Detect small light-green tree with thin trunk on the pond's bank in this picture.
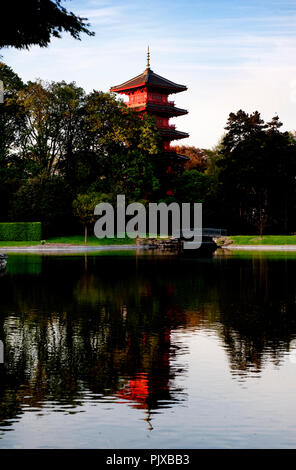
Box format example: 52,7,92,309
73,192,110,245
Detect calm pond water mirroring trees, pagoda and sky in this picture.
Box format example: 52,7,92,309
0,251,296,449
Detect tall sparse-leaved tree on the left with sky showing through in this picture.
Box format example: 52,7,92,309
17,81,85,175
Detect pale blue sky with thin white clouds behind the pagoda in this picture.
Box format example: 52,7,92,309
1,0,296,148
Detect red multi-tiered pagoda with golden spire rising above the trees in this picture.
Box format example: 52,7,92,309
110,48,189,160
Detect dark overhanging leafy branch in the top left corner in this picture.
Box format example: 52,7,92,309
0,0,94,49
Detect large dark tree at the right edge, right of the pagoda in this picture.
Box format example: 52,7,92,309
217,110,296,235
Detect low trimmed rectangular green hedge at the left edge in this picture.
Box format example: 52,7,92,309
0,222,42,241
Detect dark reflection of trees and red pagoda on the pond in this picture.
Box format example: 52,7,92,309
0,253,296,427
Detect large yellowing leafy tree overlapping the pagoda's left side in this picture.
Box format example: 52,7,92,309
78,91,160,199
